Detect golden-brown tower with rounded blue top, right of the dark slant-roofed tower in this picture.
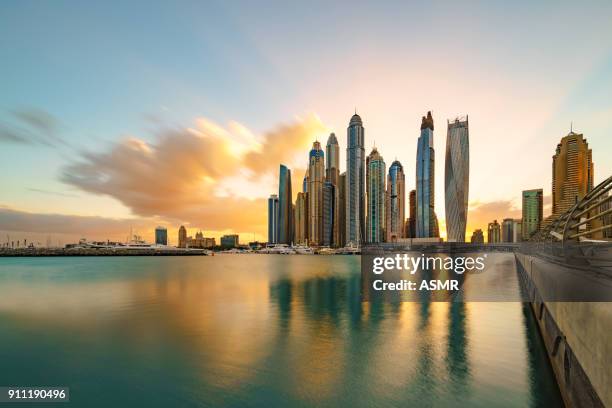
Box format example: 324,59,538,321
308,141,325,246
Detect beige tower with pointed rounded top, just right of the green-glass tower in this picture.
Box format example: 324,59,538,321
385,160,406,242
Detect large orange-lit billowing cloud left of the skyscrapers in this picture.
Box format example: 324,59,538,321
60,115,325,234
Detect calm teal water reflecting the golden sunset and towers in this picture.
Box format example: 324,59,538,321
0,255,562,407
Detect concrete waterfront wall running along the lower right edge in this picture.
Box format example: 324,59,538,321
515,252,612,407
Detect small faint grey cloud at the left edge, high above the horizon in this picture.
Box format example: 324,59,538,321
0,108,65,147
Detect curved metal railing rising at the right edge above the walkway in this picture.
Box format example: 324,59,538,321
530,176,612,242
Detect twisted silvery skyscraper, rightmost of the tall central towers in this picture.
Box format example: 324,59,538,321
444,116,470,242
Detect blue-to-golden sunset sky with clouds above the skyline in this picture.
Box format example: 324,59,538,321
0,0,612,245
